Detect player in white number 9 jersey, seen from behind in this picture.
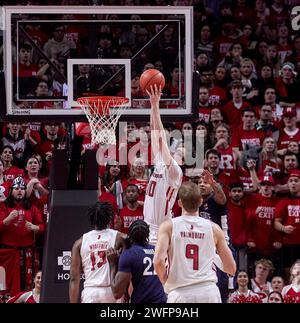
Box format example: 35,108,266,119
154,182,236,303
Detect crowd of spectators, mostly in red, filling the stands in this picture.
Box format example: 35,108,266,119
0,0,300,303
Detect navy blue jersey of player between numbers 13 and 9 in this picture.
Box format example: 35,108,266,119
118,245,167,303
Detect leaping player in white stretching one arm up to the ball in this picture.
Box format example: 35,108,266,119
144,85,182,245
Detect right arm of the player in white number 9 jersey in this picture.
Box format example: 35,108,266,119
212,222,236,276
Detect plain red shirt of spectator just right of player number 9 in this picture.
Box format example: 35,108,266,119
226,199,246,246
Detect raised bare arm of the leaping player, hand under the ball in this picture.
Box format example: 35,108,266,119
147,85,172,166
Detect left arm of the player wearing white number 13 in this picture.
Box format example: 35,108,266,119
69,238,82,303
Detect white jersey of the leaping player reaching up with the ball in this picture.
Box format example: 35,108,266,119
144,154,182,230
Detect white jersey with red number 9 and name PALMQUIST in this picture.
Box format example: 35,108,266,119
165,215,217,293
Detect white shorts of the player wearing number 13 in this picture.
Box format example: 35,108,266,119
81,287,122,303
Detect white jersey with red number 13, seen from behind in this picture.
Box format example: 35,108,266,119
80,229,118,287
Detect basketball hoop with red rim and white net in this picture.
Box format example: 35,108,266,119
77,96,129,145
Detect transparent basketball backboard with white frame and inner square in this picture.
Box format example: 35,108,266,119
1,6,196,121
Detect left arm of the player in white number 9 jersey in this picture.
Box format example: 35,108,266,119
153,220,172,284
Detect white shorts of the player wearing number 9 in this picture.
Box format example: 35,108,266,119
167,283,222,303
